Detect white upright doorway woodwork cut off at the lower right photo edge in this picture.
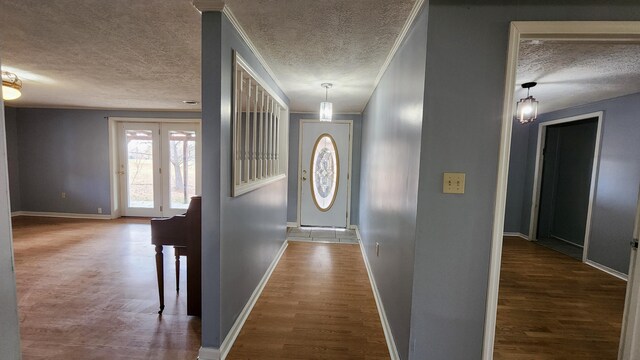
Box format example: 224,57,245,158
618,184,640,360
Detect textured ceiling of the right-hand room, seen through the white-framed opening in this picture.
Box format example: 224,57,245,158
516,40,640,113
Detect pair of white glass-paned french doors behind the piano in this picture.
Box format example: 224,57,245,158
118,122,200,217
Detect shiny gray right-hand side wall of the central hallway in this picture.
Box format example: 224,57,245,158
359,7,427,359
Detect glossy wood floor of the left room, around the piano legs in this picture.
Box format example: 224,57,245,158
11,217,200,360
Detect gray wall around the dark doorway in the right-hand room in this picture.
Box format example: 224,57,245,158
507,93,640,274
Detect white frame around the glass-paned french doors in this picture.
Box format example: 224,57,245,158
107,116,202,219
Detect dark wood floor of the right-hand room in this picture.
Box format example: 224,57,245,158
494,237,626,360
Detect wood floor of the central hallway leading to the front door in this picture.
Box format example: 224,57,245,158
227,242,389,360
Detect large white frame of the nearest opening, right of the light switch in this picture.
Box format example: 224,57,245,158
482,21,640,360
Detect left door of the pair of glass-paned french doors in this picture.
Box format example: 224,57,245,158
120,123,162,216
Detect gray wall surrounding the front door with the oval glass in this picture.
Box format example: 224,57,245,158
287,113,362,225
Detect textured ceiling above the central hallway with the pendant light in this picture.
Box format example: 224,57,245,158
227,0,415,112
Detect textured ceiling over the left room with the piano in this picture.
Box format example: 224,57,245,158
0,0,200,110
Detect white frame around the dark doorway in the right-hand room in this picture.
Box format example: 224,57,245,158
529,111,604,262
